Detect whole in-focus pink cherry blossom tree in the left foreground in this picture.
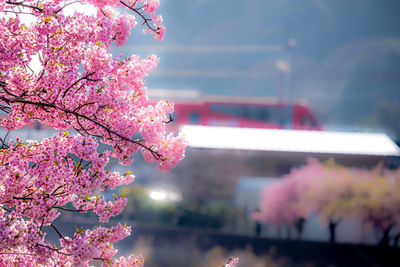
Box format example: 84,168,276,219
0,0,186,266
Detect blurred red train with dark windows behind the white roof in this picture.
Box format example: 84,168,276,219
155,96,323,130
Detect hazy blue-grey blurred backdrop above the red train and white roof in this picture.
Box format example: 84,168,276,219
129,0,400,140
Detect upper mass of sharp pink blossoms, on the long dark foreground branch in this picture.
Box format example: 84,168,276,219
0,1,185,172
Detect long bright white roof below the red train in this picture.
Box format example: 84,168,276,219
180,125,400,156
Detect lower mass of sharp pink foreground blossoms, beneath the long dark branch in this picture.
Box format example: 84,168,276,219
0,134,142,263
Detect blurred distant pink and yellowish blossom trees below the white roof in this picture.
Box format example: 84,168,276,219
254,159,400,245
